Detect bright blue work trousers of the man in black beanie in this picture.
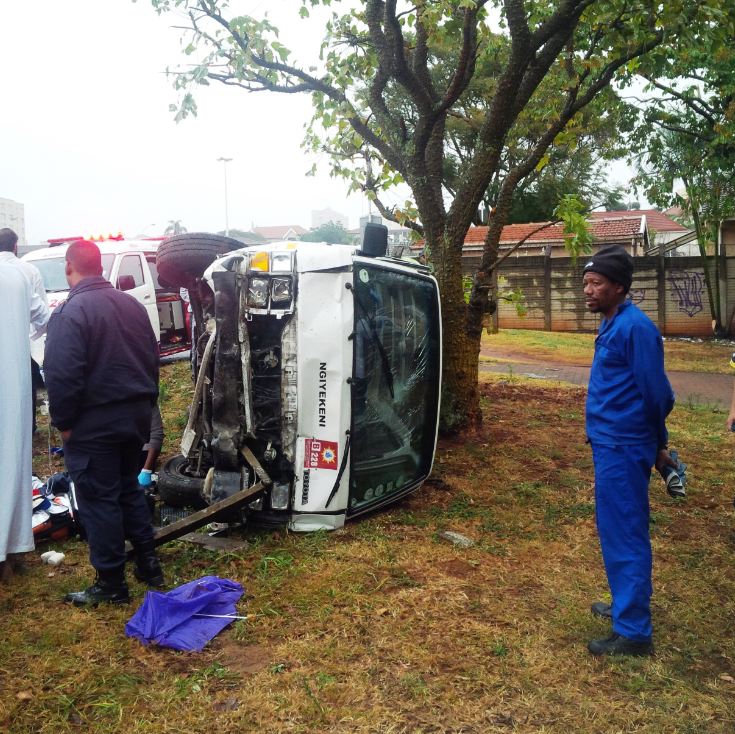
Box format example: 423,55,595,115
592,444,656,641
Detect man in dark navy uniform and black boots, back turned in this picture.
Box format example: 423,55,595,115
44,240,163,606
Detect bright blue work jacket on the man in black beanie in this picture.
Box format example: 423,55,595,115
587,301,674,448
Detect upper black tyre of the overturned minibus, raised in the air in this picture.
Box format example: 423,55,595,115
156,232,245,288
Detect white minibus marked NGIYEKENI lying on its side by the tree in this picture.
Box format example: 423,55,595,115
157,225,442,531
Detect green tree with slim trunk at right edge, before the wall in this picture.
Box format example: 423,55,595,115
634,44,735,335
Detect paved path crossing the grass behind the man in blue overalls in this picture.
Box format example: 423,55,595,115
480,362,733,410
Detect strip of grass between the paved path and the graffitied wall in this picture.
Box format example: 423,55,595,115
480,329,735,374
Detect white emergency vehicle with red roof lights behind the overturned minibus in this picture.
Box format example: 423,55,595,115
22,238,191,364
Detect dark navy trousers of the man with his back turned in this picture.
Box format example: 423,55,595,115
64,401,153,572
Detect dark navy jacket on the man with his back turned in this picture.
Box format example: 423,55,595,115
43,276,159,431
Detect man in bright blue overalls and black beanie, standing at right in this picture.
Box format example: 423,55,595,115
584,245,675,655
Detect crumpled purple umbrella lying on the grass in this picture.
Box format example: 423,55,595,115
125,576,243,652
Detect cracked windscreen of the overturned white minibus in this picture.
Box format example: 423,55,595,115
349,263,440,513
